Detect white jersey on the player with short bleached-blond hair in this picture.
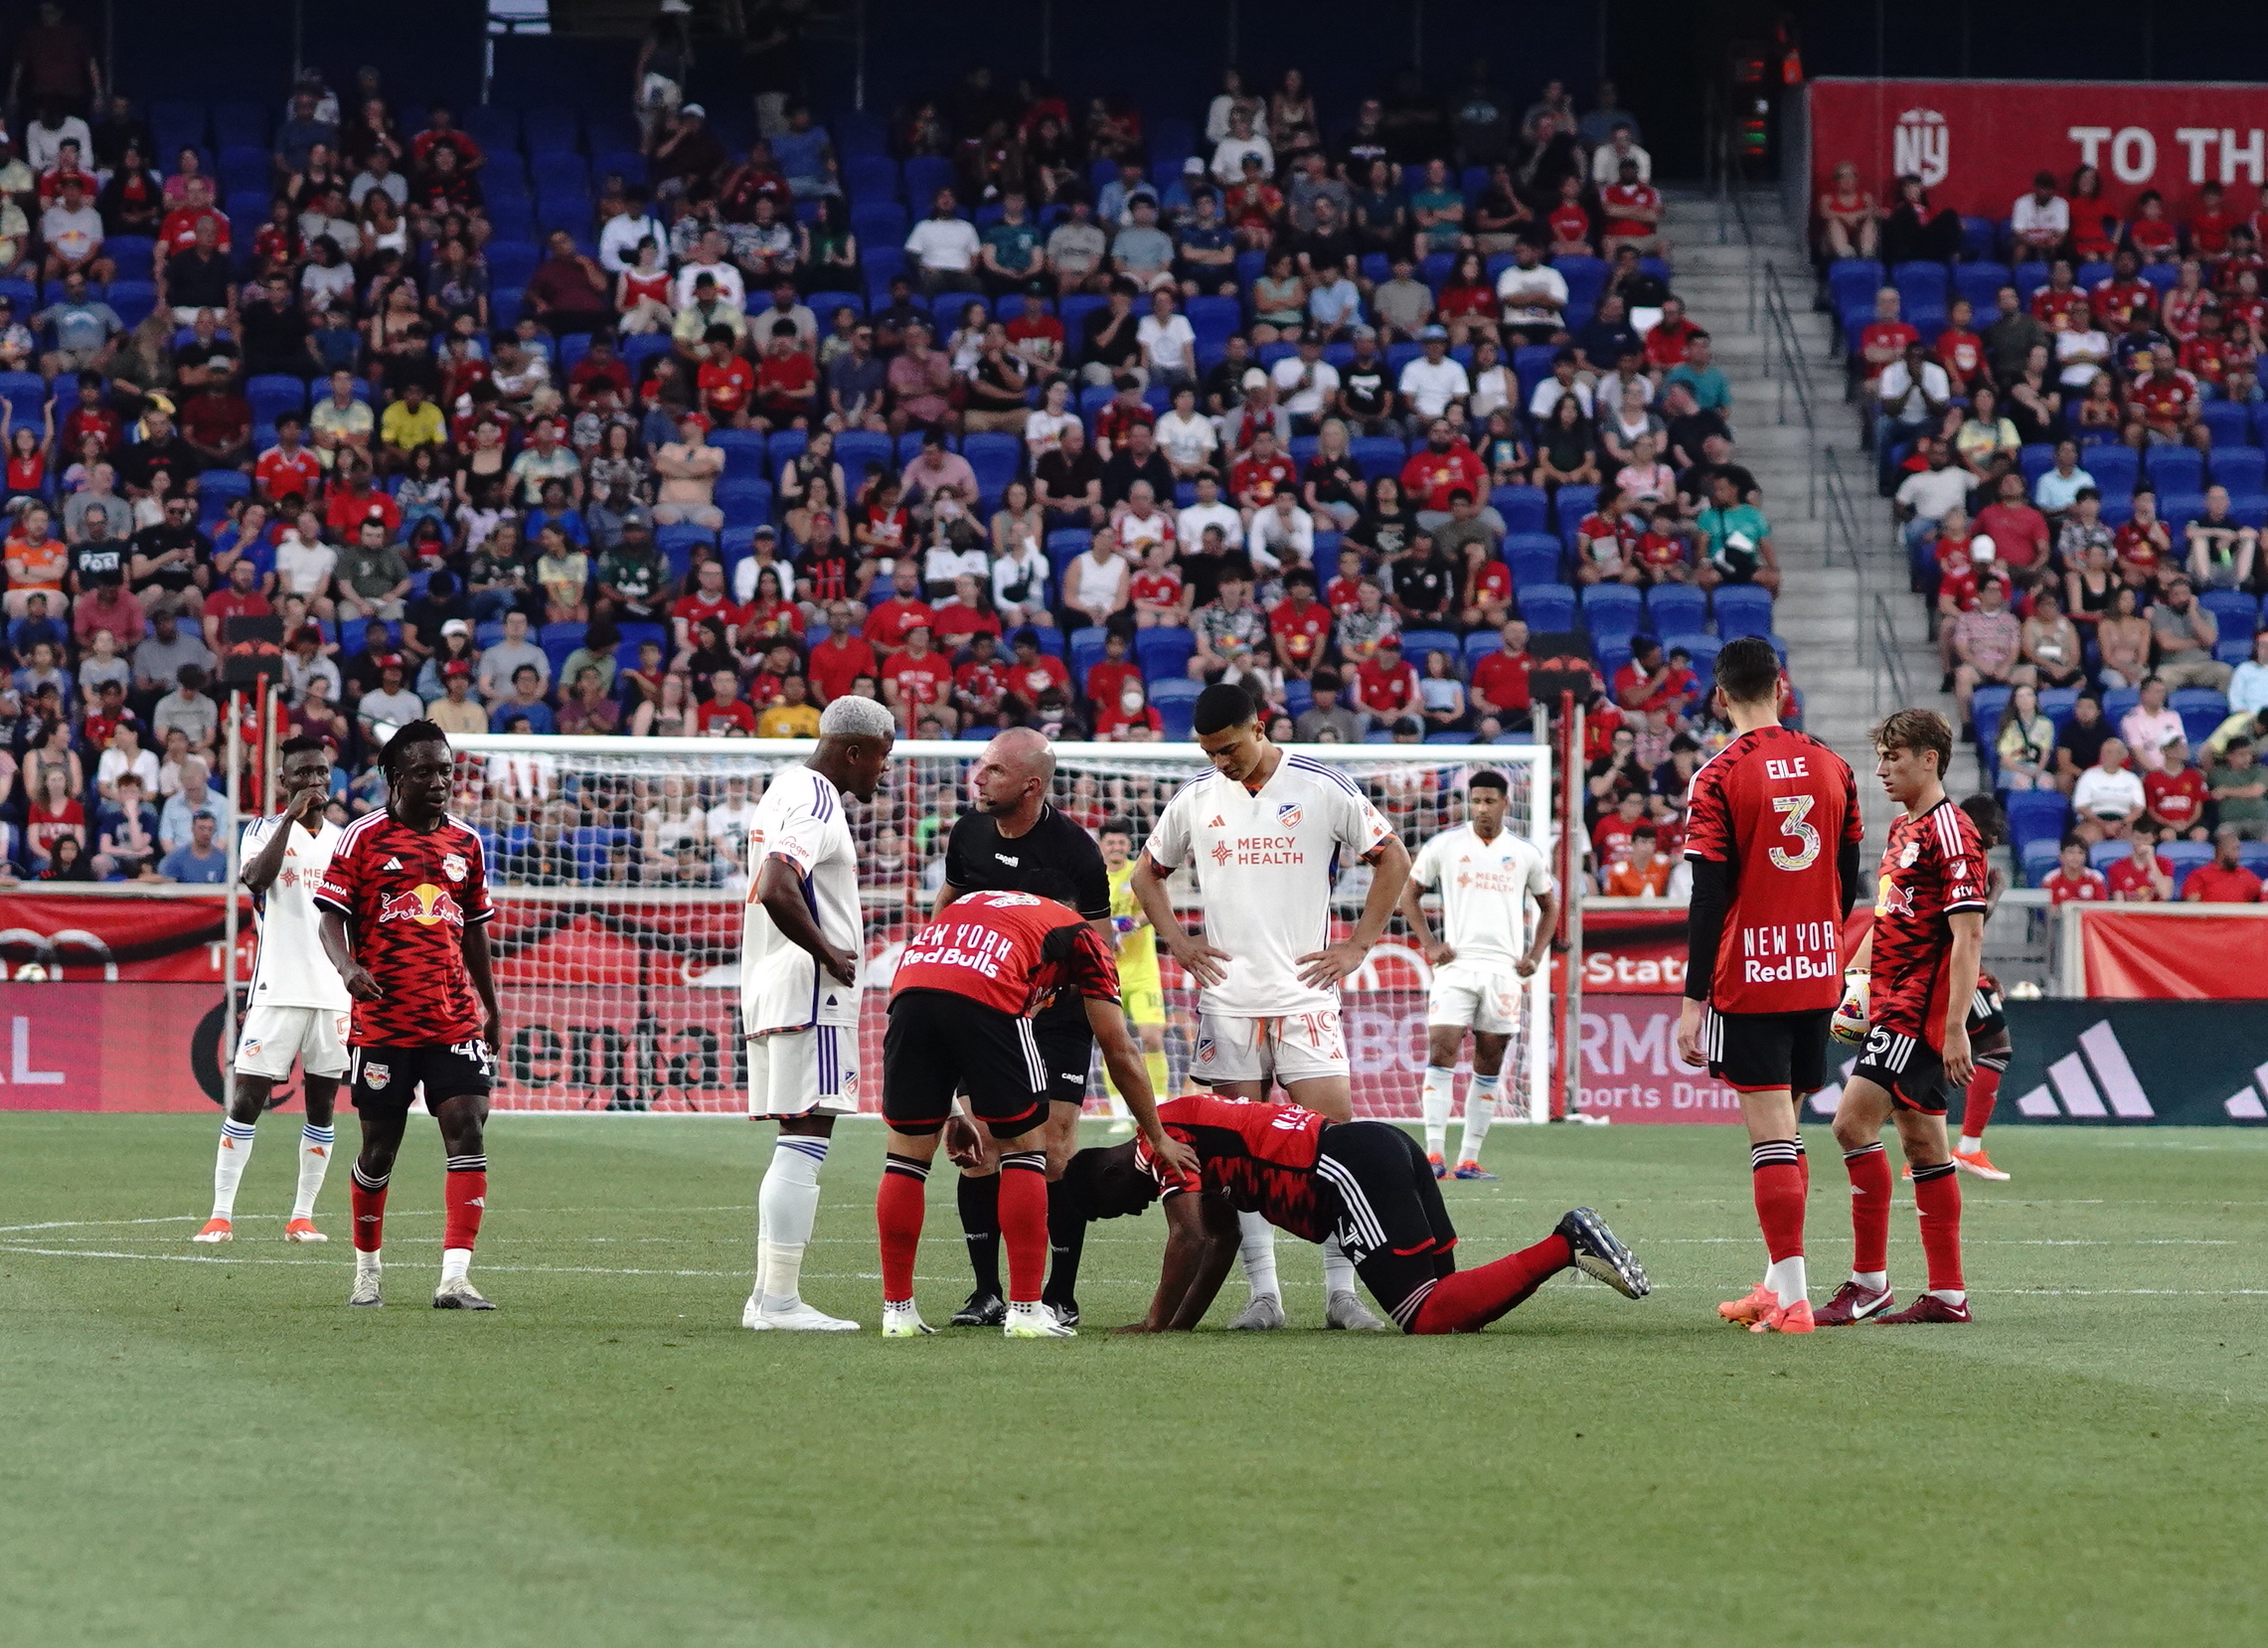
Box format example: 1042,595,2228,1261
739,761,867,1036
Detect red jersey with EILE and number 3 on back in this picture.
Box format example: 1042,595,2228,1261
1686,728,1864,1013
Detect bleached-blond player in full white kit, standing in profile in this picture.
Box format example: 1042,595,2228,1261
739,696,895,1333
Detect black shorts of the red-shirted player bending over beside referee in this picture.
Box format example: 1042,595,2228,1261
883,991,1052,1138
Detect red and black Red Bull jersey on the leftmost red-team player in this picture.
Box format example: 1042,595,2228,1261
315,811,497,1048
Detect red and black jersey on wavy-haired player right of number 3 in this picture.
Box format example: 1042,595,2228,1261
1866,795,1987,1052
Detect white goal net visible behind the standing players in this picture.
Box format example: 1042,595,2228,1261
432,737,1551,1120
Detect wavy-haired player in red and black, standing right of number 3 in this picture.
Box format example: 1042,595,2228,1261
1817,710,1987,1328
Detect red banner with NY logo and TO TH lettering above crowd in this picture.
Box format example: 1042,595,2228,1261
1805,80,2268,220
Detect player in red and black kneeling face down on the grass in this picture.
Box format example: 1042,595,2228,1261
1063,1095,1649,1333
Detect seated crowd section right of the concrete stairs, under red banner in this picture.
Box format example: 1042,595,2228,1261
1817,163,2268,903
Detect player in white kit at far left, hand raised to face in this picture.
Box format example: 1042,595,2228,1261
188,739,354,1242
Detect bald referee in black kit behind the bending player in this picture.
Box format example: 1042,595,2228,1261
930,728,1111,1328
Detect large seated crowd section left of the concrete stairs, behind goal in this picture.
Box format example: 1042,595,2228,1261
0,16,1805,880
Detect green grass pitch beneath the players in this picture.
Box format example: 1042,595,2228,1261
0,1113,2268,1648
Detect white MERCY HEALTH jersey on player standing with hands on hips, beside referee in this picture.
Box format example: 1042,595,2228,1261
1145,754,1392,1018
